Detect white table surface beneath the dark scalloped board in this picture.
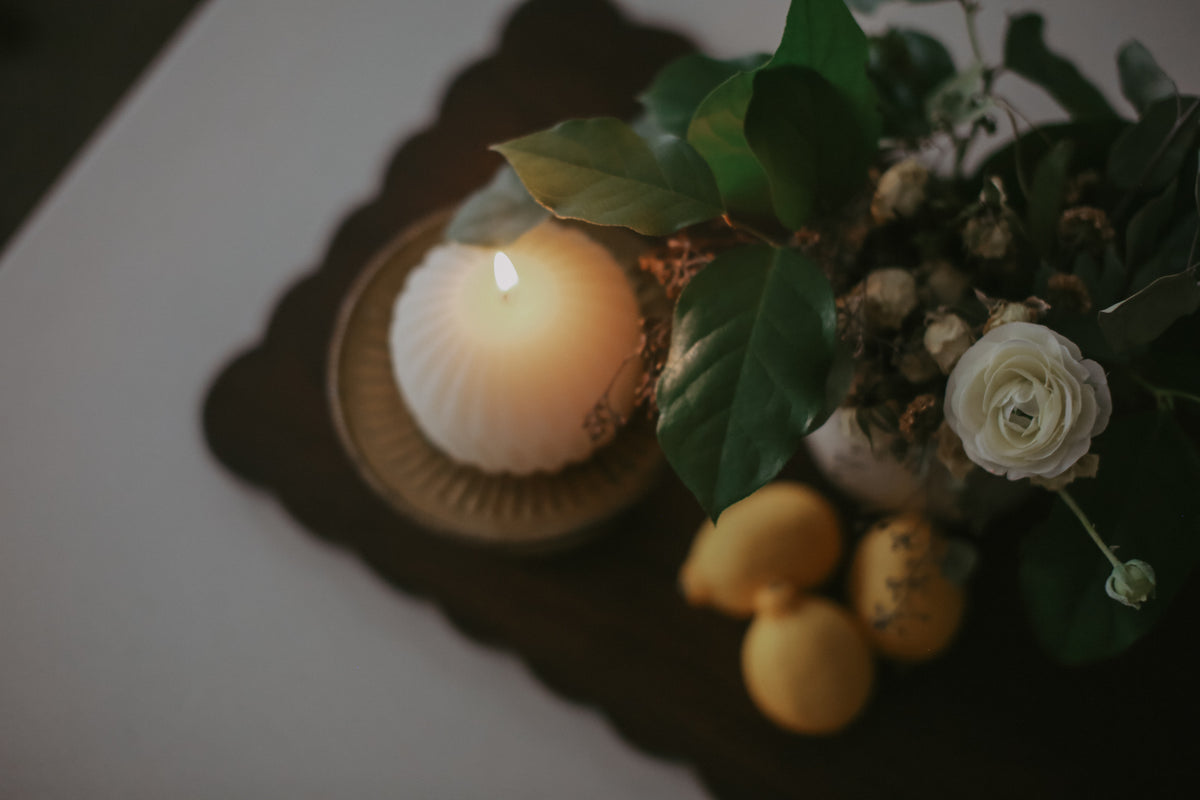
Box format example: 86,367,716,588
0,0,1200,800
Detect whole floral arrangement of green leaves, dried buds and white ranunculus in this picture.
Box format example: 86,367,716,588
448,0,1200,663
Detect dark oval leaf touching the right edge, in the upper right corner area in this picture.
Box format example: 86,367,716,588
1108,97,1200,192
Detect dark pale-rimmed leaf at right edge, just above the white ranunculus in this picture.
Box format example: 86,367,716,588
1099,269,1200,353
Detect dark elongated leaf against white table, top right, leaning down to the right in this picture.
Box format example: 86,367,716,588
1004,13,1116,118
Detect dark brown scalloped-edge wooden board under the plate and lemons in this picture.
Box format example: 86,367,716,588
204,0,1200,798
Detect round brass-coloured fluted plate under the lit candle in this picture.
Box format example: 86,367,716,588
328,211,664,551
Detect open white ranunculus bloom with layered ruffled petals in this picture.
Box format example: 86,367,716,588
946,323,1112,481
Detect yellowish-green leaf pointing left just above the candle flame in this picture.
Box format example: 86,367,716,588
492,118,722,236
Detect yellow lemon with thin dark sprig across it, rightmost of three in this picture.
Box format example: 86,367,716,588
850,513,965,662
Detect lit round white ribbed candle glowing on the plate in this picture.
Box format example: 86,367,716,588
391,221,641,475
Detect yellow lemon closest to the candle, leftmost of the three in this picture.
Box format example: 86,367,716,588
679,481,841,616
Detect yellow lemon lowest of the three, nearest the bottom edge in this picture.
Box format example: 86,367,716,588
742,596,875,734
